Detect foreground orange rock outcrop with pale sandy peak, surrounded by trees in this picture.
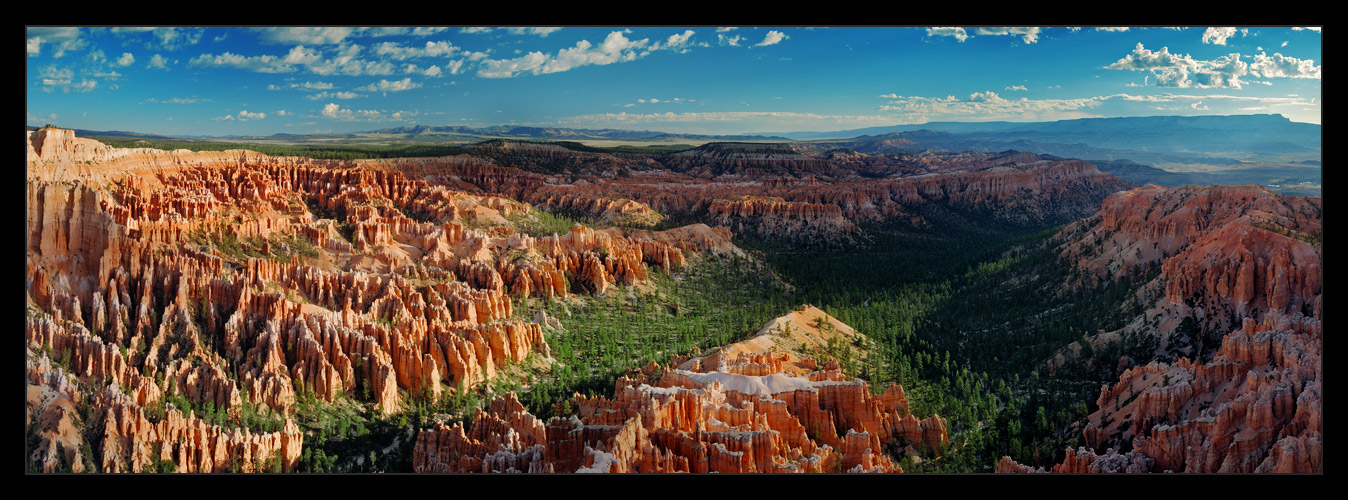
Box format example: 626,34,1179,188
414,307,949,473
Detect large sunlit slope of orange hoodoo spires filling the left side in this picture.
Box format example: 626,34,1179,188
24,129,740,472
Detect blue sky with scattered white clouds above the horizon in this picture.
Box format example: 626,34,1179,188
26,27,1322,136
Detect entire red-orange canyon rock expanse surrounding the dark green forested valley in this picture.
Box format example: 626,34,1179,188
24,128,1322,473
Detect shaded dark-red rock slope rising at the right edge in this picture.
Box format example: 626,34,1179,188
998,186,1324,473
